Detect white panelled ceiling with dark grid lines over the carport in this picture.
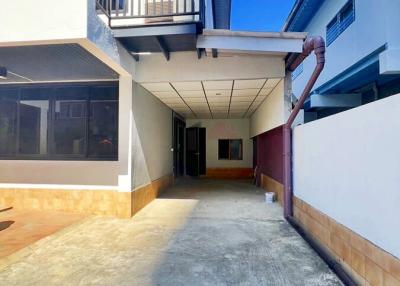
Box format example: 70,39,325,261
142,78,281,119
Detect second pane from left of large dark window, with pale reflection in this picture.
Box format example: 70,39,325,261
18,89,50,155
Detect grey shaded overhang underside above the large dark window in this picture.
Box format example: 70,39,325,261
0,44,118,84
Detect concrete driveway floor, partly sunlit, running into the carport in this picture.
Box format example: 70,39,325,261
0,179,342,286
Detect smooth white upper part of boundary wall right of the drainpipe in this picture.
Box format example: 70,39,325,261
293,95,400,257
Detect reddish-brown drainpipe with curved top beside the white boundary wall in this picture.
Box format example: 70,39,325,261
283,37,325,218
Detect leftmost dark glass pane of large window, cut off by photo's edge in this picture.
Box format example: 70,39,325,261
0,90,18,155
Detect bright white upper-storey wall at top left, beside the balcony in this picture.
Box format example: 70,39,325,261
0,0,135,76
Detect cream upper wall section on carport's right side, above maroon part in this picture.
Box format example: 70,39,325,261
250,79,287,137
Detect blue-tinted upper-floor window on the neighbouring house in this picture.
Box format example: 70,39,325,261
326,0,355,46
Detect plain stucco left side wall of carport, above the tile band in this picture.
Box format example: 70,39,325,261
132,83,173,189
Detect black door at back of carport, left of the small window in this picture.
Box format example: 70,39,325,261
186,127,206,176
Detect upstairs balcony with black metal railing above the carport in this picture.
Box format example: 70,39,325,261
96,0,205,61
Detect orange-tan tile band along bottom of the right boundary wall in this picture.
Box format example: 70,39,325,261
293,197,400,286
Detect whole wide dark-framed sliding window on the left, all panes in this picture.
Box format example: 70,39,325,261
0,83,118,160
